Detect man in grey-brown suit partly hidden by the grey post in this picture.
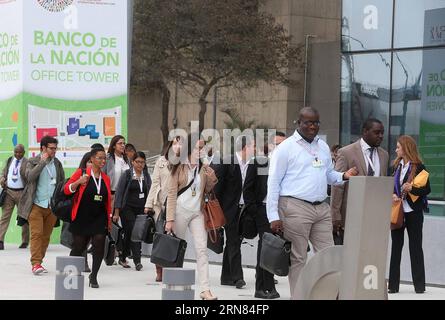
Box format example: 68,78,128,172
331,118,389,244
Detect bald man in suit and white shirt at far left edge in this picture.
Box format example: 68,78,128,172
0,144,29,250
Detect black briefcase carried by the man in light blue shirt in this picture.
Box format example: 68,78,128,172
260,232,291,277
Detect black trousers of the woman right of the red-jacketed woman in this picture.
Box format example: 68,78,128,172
119,206,144,264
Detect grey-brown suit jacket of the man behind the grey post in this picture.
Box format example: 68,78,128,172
331,139,389,227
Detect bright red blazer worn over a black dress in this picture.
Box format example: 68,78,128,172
63,168,111,226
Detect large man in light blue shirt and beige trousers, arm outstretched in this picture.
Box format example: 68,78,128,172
267,107,357,299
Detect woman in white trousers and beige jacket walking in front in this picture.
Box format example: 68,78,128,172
165,135,218,300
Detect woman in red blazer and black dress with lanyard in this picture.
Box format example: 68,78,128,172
64,149,111,288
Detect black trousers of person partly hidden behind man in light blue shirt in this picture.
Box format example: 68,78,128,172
255,205,275,291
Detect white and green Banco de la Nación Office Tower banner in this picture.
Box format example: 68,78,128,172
0,0,128,243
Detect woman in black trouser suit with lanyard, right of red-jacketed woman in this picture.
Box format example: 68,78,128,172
113,151,151,271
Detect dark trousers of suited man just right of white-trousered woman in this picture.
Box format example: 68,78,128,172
221,208,243,282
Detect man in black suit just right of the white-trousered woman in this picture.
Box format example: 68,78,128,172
215,135,255,289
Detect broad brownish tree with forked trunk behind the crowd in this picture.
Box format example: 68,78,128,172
132,0,301,142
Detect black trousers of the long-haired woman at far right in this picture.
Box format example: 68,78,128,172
388,211,425,291
